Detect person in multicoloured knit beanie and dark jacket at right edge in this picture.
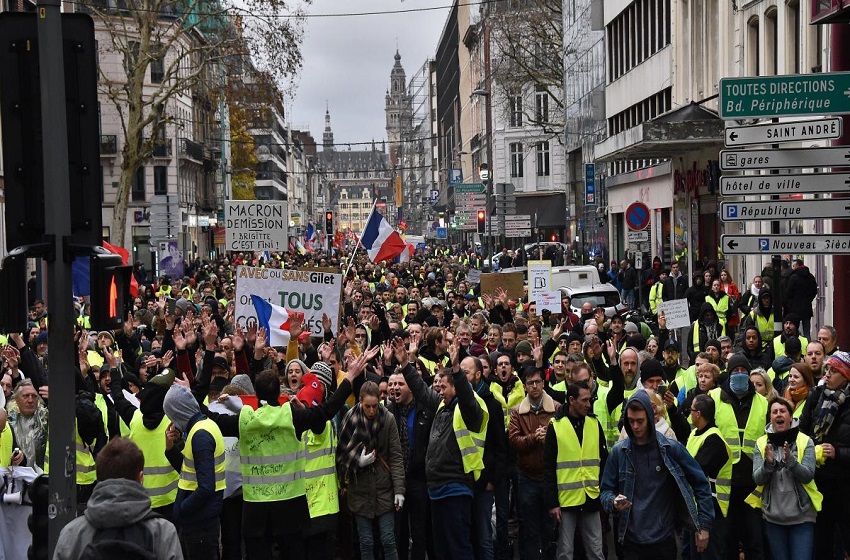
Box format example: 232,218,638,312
800,351,850,558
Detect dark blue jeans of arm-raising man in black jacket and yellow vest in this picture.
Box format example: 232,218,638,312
431,496,474,560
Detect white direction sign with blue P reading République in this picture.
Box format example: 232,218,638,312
720,198,850,222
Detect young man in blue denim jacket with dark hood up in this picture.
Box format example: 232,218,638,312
601,391,714,560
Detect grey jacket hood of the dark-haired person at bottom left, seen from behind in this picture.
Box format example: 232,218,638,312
85,478,151,529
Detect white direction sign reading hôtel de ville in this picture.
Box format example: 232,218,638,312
720,173,850,196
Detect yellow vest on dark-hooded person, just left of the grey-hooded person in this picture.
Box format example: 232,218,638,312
128,410,180,508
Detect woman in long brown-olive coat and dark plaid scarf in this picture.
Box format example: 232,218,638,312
337,381,404,560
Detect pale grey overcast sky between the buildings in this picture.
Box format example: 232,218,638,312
287,0,451,150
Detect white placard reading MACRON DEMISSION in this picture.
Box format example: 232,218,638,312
224,200,289,251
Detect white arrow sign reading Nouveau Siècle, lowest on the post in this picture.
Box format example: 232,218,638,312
720,234,850,255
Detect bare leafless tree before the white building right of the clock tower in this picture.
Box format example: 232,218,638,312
487,0,564,142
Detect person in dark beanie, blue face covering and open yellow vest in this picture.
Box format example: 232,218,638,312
708,353,768,558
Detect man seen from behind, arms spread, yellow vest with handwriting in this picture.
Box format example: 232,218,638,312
200,347,380,558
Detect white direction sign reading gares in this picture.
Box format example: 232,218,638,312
720,146,850,171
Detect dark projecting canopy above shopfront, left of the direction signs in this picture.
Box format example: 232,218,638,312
596,102,725,162
